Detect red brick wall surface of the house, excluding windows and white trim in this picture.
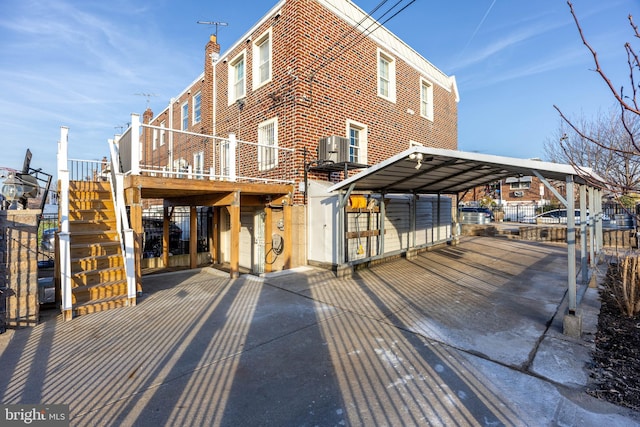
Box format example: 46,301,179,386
145,0,457,203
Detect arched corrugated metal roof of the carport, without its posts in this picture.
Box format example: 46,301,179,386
328,146,604,194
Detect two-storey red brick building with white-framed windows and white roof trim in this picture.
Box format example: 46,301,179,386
143,0,458,204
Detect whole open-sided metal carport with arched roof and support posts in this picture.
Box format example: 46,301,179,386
328,146,605,335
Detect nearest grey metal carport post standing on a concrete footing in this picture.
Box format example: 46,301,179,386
563,175,582,338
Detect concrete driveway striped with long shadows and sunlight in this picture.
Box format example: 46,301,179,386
0,237,640,427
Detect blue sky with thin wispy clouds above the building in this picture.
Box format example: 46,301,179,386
0,0,640,176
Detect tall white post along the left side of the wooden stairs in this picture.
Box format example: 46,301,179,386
57,126,73,320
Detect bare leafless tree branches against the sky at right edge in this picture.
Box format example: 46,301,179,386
547,1,640,195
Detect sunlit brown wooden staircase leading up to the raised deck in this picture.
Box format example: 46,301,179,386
69,181,128,316
